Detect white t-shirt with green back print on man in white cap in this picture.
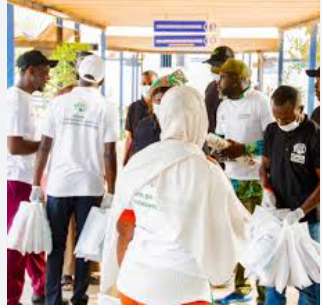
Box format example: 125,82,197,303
42,87,118,197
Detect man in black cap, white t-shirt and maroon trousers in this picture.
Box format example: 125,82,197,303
7,50,57,305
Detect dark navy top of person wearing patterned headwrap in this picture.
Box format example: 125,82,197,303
134,114,161,153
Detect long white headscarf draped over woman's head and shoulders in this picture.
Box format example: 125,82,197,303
101,86,249,295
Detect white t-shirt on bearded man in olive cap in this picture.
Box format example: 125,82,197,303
216,88,274,180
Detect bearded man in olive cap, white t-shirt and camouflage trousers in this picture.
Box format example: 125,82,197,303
216,59,273,305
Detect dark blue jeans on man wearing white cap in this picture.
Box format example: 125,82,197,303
46,196,102,305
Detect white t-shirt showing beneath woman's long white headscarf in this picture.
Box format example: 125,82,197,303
117,180,211,305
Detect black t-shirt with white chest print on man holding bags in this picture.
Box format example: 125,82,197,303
264,117,320,222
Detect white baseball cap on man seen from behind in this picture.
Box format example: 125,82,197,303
78,55,105,84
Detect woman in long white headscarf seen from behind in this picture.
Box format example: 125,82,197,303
100,86,249,305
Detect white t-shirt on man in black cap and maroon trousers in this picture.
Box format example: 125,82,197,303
7,86,36,184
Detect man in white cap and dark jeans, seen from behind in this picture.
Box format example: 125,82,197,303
30,55,118,305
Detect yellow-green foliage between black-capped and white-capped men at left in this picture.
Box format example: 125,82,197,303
44,42,90,98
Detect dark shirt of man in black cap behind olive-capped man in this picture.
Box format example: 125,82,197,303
205,81,222,133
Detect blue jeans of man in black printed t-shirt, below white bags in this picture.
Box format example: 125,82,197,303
265,223,320,305
